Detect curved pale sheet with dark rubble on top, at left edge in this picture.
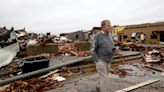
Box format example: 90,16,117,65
0,28,19,67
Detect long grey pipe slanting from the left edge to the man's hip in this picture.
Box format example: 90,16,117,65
0,56,92,86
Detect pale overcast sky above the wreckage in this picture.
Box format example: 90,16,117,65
0,0,164,34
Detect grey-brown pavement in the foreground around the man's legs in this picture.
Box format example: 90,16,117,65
45,69,164,92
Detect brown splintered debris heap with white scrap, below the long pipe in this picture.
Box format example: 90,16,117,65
0,63,88,92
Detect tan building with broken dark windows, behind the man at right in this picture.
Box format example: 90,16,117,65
117,22,164,44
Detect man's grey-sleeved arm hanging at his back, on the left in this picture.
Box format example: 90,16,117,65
91,36,99,62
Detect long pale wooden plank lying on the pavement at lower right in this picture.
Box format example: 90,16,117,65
115,79,159,92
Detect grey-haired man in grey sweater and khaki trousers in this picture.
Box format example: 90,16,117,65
91,20,118,92
